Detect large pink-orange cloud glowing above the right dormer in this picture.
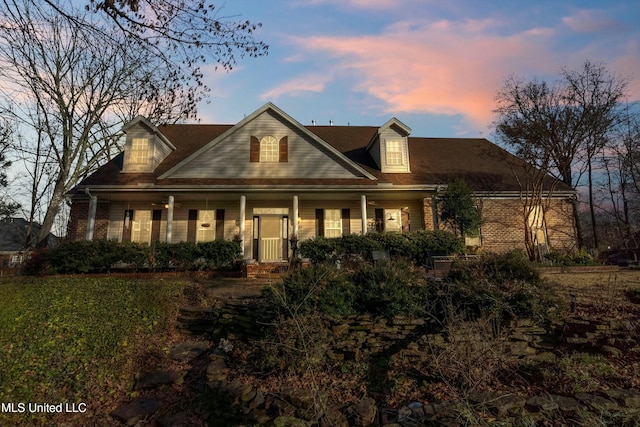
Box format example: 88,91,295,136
272,20,553,126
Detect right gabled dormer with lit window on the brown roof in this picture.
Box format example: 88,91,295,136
367,117,411,173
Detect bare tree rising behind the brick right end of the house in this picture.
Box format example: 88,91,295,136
494,61,626,251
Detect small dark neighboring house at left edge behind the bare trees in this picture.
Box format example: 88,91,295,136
0,218,57,268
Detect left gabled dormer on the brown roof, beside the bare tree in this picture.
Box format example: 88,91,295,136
122,116,176,173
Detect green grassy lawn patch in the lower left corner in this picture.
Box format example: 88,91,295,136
0,278,184,425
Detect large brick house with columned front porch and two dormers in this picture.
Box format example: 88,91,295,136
67,103,575,262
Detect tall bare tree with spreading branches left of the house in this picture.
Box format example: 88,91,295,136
0,0,268,238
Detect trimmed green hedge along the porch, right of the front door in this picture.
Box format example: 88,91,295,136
300,230,464,264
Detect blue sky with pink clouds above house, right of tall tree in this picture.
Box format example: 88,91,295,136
199,0,640,139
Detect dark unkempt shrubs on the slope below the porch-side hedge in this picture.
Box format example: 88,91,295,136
265,252,558,324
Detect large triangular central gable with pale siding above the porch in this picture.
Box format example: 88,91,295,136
159,103,376,180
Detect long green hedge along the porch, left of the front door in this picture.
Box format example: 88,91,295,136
22,240,240,275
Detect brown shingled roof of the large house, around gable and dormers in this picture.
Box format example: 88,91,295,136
72,124,572,192
